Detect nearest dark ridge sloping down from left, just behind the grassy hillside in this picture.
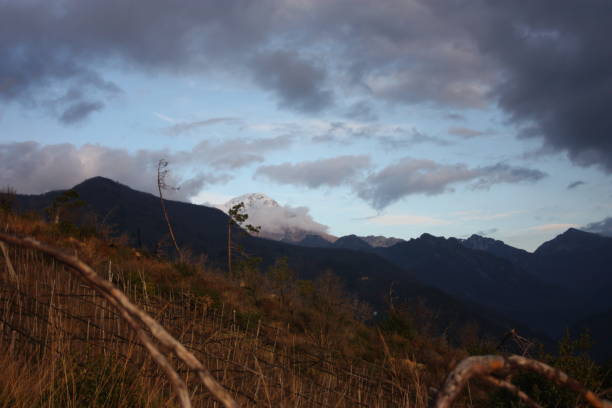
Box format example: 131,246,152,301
18,177,527,335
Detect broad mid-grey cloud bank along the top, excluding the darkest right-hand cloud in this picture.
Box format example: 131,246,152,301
0,0,490,118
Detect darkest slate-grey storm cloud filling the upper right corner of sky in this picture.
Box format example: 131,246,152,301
428,0,612,172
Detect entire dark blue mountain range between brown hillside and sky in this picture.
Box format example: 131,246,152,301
18,177,612,358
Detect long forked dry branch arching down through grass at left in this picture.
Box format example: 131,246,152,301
0,232,238,408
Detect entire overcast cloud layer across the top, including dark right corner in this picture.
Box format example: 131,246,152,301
0,0,612,172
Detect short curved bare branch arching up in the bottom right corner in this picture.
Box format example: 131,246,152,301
434,355,612,408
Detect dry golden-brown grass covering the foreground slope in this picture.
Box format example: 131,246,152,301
0,215,440,407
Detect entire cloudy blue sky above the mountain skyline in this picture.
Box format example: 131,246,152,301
0,0,612,251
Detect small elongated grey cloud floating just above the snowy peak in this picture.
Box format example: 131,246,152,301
255,156,370,188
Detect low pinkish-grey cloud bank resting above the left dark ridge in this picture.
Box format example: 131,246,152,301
0,137,287,199
